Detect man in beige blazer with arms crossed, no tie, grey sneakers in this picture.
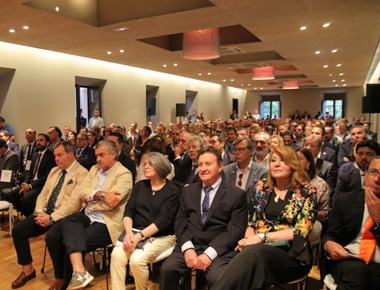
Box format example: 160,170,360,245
46,140,132,289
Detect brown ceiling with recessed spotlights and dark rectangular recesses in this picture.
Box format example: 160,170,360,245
0,0,380,90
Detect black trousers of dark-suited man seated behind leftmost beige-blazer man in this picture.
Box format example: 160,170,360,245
11,187,42,216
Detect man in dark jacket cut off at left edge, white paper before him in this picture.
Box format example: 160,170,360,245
0,139,19,196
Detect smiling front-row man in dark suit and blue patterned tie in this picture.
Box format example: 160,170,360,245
160,147,248,290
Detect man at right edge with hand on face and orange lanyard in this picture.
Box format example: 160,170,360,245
322,157,380,290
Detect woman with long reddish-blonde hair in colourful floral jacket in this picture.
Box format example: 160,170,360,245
211,147,316,290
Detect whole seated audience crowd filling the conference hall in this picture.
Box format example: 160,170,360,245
0,110,380,290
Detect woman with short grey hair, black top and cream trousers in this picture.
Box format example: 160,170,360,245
111,152,179,290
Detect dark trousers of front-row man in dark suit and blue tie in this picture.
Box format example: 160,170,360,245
160,247,236,290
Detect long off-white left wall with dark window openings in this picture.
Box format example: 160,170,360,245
0,42,246,143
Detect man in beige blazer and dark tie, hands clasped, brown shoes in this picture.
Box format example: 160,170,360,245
12,142,87,288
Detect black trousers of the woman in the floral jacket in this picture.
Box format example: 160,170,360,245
212,244,310,290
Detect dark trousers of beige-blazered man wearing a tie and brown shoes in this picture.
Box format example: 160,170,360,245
12,215,60,265
